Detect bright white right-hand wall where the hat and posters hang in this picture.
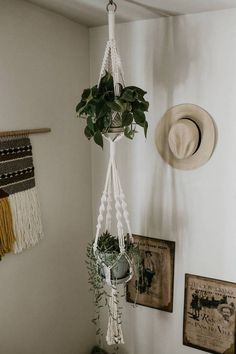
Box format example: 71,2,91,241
90,10,236,354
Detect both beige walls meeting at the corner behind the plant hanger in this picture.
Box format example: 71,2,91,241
0,0,236,354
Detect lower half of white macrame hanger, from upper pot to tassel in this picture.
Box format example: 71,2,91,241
93,140,134,345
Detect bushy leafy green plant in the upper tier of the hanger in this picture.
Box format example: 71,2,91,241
76,71,149,148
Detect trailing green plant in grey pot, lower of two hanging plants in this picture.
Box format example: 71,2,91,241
86,231,141,343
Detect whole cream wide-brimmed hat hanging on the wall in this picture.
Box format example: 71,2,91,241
155,104,216,170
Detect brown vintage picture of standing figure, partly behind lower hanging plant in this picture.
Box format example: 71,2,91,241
126,235,175,312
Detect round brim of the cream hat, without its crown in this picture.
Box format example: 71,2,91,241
155,104,216,170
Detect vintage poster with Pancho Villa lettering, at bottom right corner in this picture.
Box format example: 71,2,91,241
183,274,236,354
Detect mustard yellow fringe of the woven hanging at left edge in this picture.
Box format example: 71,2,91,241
0,197,16,259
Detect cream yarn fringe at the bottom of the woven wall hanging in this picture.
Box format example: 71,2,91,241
9,187,43,253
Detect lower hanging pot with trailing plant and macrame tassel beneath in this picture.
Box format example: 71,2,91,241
86,231,141,344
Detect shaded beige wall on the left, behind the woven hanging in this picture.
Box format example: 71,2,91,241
0,0,94,354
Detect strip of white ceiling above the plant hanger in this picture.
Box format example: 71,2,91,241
27,0,236,26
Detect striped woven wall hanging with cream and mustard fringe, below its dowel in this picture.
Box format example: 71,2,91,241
0,136,43,257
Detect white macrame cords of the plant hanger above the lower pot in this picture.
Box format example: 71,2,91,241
93,0,133,258
